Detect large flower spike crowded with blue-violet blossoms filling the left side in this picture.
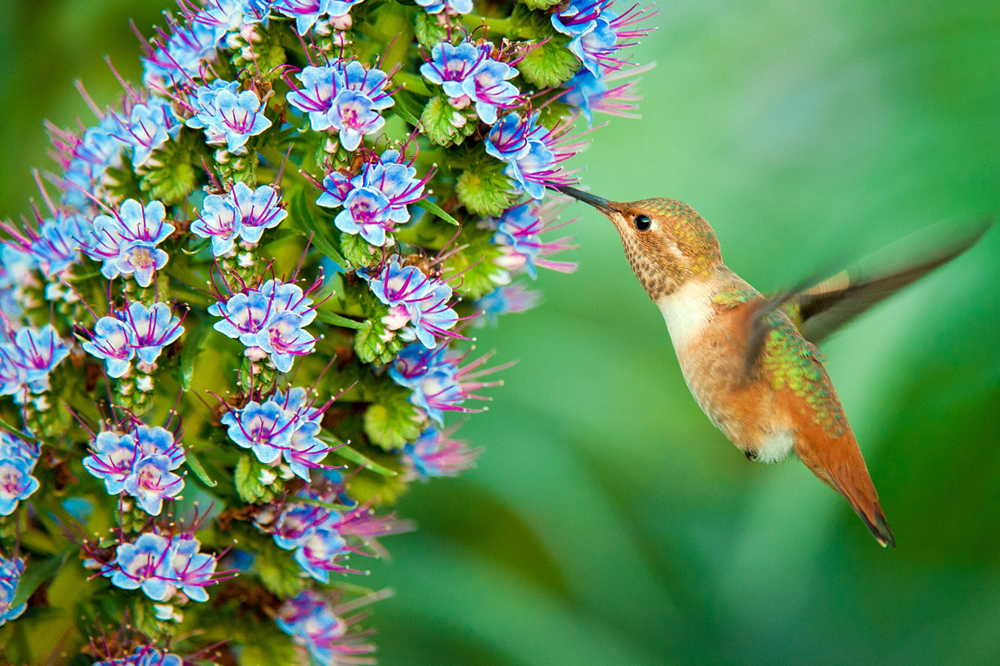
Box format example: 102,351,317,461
0,0,655,666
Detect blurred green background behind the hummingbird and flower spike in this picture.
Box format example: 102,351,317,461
0,0,1000,666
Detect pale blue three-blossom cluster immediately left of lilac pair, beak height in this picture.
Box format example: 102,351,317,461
84,199,174,287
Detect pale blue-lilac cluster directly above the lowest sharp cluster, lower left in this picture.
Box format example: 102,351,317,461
83,425,184,516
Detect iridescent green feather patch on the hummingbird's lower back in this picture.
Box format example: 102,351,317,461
760,310,847,437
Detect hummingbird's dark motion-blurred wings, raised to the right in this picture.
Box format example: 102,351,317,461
746,217,993,371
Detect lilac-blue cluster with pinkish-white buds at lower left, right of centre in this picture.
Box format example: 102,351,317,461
361,259,458,349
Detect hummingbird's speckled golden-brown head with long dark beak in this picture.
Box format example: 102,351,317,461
559,186,722,301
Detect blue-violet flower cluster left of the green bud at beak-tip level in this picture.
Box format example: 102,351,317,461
316,150,427,247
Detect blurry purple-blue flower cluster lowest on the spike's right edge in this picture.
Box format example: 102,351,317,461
277,590,375,664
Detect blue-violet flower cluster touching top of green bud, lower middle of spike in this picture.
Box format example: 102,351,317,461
222,387,330,474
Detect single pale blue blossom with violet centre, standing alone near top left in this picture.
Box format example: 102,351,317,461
187,79,271,155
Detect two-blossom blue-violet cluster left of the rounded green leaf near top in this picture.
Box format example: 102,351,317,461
420,42,520,125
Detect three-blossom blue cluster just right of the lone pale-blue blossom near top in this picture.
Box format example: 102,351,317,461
286,60,395,150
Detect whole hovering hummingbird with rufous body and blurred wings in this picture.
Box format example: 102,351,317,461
556,186,992,548
